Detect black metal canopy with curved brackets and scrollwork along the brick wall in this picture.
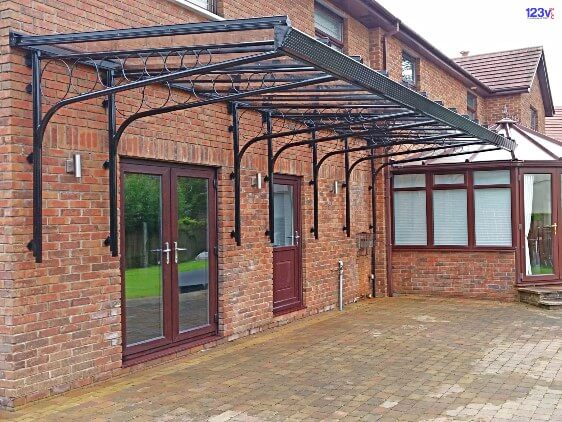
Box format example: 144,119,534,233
10,16,515,262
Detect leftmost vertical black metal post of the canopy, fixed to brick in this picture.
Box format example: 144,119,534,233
27,51,42,263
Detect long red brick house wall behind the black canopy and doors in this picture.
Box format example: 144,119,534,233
0,0,376,408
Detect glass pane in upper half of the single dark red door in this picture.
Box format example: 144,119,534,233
273,184,295,246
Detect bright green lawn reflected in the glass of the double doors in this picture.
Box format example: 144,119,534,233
125,259,208,299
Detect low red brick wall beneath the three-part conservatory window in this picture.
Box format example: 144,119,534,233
392,250,516,300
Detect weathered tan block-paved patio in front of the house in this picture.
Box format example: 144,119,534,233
4,298,562,422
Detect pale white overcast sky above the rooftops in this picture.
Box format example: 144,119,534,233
377,0,562,106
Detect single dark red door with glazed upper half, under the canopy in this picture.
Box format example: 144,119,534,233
273,175,302,313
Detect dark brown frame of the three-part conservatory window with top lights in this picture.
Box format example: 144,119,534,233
389,165,517,252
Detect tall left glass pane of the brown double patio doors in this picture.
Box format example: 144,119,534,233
124,173,163,346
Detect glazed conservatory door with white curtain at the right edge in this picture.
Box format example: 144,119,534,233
521,168,562,283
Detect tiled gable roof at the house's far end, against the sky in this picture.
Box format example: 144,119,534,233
453,47,554,116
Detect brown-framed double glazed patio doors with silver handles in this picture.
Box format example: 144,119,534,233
121,161,217,357
